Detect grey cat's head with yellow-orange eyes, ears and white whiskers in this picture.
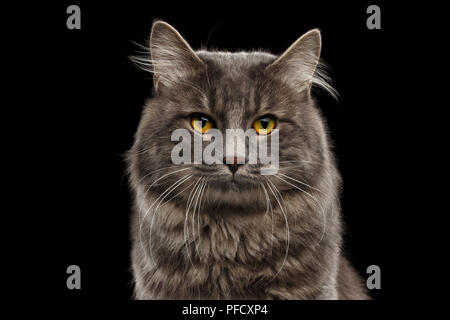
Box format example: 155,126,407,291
128,22,328,213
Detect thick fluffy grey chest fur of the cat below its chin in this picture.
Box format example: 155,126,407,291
133,195,336,299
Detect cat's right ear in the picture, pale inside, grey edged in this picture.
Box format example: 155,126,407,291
267,29,321,90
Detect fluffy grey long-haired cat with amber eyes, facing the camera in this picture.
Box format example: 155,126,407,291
126,21,370,299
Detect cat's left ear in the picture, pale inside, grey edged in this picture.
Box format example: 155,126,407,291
150,21,203,90
